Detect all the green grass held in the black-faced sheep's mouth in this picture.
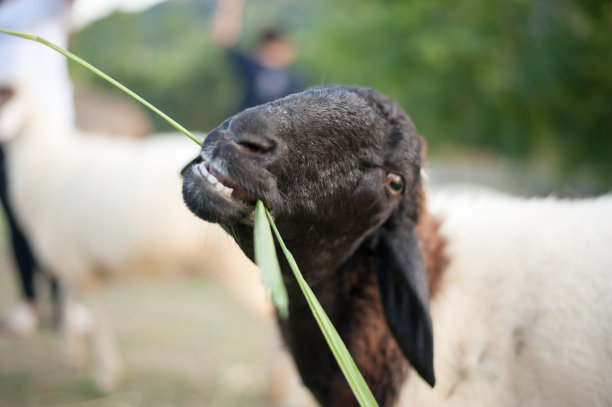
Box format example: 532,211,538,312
0,28,378,407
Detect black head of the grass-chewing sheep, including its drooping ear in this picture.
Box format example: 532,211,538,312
183,86,434,385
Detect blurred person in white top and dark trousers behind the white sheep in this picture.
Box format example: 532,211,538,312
0,0,75,335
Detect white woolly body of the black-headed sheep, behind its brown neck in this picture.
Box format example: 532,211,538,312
398,192,612,407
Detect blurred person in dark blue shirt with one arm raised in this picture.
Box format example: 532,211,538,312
212,0,300,110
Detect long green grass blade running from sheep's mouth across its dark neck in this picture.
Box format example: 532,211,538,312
258,201,378,407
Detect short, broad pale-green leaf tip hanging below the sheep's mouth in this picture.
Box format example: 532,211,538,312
253,201,289,318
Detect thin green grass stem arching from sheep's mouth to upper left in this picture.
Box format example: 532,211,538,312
0,28,202,145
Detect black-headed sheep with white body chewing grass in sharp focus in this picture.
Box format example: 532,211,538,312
183,85,612,406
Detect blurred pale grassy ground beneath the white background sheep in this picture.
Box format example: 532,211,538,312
0,218,278,407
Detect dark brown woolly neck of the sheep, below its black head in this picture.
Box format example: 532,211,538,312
280,249,408,406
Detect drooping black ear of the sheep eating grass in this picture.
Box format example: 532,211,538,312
375,230,436,387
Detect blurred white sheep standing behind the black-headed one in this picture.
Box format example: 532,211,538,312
0,83,270,392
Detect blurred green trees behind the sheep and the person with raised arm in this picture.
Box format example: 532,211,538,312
73,0,612,189
